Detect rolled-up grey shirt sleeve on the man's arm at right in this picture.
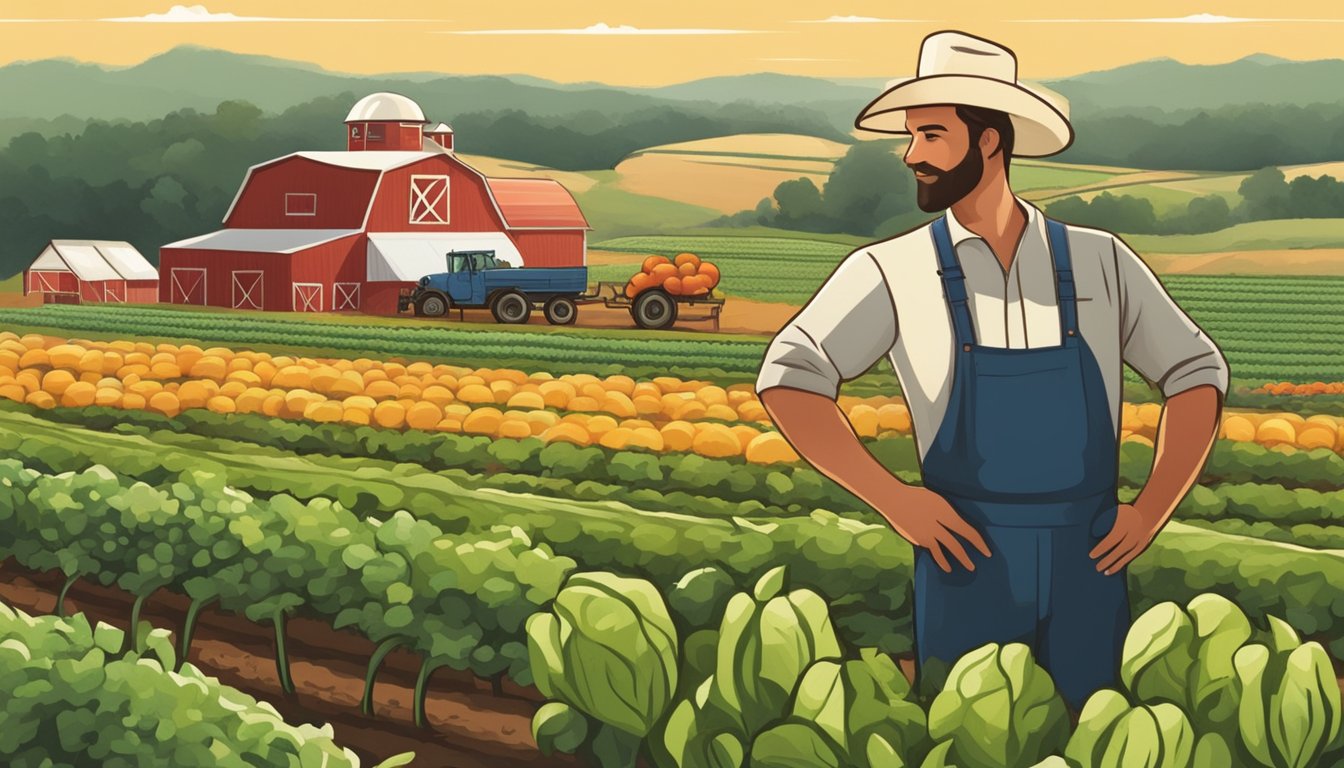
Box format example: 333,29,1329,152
1113,238,1228,397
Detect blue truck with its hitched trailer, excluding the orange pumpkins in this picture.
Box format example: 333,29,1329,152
396,250,724,331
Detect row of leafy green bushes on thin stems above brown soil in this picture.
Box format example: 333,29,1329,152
0,459,575,721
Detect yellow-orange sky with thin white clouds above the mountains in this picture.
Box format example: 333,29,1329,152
0,0,1344,86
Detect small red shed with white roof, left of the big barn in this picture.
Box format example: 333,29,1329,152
23,239,159,304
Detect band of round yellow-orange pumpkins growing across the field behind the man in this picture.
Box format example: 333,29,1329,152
0,332,1344,463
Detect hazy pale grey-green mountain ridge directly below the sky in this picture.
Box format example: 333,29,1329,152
0,46,1344,140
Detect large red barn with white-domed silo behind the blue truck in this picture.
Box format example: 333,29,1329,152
159,93,591,313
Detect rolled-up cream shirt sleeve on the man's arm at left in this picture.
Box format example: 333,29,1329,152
755,250,896,399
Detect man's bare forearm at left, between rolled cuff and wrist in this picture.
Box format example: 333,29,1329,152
761,386,909,507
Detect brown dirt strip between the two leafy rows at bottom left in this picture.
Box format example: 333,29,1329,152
0,561,579,768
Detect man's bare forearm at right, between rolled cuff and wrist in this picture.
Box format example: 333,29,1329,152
1134,385,1223,521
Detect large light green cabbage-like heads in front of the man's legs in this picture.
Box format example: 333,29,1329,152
527,566,1344,768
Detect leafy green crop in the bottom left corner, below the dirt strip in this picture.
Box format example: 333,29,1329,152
0,599,413,768
